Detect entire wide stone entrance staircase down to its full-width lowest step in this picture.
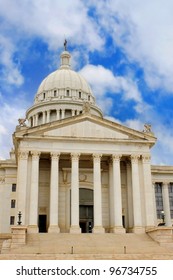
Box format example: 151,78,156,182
0,233,173,260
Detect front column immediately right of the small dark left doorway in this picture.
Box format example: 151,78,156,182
48,152,60,233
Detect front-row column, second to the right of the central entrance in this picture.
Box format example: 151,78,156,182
112,155,125,233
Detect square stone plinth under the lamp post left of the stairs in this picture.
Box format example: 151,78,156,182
11,226,27,248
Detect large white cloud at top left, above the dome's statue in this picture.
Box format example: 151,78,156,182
0,0,104,50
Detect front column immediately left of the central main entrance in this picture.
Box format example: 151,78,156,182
70,153,81,233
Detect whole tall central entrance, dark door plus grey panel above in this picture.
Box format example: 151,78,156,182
79,189,94,233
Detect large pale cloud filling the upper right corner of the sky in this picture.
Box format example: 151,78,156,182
90,0,173,92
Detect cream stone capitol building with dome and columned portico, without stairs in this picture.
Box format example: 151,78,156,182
0,48,173,258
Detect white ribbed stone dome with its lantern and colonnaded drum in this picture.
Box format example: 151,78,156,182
26,50,102,127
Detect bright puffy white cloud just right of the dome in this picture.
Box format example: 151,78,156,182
79,64,142,114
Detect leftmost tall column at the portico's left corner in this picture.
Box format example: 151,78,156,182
17,151,29,225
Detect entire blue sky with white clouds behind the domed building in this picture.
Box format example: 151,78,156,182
0,0,173,165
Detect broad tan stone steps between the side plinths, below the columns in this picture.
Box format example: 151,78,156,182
4,233,173,255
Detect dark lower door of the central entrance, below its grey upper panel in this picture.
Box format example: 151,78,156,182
79,205,93,233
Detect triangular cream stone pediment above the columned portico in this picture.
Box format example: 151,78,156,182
17,115,156,143
